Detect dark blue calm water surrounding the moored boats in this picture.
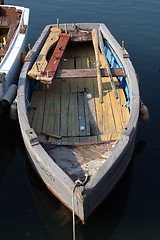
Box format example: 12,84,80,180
0,0,160,240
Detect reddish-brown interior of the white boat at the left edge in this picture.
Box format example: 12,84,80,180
0,6,22,62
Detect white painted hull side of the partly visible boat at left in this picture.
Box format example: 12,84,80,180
0,5,29,100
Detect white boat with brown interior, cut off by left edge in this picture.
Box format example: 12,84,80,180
0,1,29,115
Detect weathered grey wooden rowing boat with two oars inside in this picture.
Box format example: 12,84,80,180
17,23,140,222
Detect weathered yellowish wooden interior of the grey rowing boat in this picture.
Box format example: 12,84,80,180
28,26,130,180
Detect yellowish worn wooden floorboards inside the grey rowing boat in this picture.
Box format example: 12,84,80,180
28,39,129,142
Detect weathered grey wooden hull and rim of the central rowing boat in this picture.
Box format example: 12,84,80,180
18,24,139,222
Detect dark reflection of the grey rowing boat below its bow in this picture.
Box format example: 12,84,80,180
26,141,145,240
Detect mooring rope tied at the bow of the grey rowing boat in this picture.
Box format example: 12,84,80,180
72,174,88,240
